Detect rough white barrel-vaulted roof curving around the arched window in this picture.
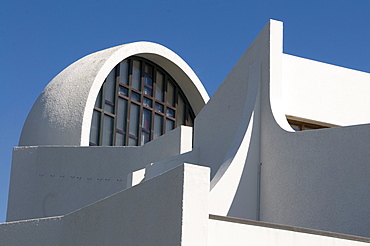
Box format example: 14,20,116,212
19,42,209,146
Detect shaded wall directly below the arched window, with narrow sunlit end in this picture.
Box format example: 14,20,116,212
7,126,192,221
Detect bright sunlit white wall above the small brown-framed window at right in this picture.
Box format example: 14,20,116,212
282,54,370,126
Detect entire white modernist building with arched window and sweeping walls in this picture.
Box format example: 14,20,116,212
0,20,370,246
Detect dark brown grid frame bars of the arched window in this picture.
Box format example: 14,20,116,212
89,56,195,146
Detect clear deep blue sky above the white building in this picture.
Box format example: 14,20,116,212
0,0,370,223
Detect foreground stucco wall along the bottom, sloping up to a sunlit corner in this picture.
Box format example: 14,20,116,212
5,161,370,246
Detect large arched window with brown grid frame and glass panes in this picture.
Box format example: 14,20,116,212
90,57,194,146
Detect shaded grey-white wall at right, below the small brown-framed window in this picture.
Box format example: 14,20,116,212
261,125,370,237
